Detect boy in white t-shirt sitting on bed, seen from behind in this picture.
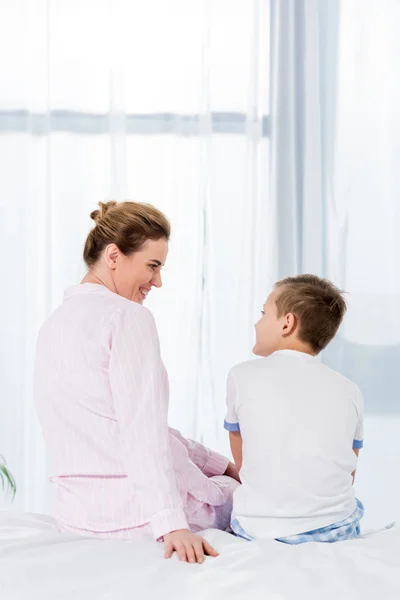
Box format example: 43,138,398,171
225,275,363,544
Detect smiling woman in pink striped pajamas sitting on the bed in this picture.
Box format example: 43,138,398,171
35,202,239,562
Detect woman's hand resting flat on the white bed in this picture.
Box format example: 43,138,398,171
164,529,218,563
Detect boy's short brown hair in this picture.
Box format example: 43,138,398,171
275,275,347,354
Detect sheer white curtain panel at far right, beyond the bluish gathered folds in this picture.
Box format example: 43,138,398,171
328,0,400,521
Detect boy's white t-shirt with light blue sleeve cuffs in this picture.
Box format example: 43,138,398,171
225,350,363,538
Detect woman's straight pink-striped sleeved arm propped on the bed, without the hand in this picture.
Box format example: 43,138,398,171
109,305,188,539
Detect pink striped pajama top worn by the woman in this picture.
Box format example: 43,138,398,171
35,283,228,539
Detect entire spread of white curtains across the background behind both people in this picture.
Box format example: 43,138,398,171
0,0,400,519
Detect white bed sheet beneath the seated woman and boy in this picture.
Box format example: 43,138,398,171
0,512,400,600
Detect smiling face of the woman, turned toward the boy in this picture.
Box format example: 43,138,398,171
104,238,168,304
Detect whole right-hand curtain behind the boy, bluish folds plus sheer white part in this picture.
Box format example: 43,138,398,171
271,0,400,523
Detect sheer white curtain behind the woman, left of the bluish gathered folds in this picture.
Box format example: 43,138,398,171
0,0,269,511
